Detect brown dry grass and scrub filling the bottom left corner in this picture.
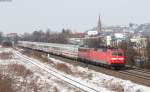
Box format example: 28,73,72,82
0,64,41,92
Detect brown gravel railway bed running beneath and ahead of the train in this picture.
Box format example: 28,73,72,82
18,48,150,86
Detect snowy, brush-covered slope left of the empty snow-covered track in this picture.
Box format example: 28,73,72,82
0,48,81,92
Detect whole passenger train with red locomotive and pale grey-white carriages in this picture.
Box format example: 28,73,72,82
18,41,125,68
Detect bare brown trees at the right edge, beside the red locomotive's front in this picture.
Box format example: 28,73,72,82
119,37,150,69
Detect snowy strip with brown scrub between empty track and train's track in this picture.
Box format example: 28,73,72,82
49,57,150,92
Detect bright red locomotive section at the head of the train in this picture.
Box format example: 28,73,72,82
78,48,125,67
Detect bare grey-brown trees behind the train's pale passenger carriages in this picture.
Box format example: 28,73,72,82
20,29,73,43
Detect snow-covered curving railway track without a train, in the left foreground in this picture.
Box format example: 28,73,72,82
14,51,100,92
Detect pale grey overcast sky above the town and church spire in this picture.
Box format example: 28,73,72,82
0,0,150,33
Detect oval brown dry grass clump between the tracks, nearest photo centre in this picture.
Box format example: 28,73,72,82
55,63,73,74
